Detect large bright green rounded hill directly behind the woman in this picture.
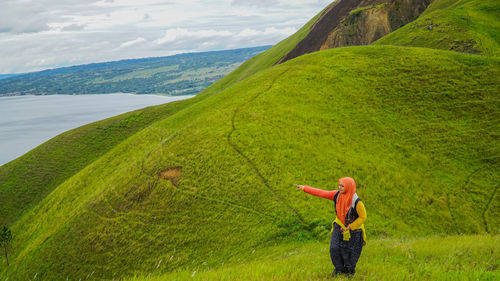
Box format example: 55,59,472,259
2,46,500,279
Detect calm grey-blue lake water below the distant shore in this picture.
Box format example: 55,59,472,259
0,94,192,165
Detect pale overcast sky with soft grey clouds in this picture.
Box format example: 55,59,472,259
0,0,333,74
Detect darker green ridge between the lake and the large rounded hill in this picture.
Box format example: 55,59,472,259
0,6,319,228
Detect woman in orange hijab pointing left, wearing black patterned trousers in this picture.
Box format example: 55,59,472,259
294,178,366,275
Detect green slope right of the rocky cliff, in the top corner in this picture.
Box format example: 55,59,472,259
373,0,500,57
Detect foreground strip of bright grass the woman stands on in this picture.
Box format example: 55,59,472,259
126,235,500,281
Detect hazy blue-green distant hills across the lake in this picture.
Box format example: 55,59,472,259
0,46,269,96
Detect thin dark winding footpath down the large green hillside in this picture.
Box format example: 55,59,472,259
227,69,304,224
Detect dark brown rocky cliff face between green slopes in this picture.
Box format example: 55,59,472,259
279,0,432,63
